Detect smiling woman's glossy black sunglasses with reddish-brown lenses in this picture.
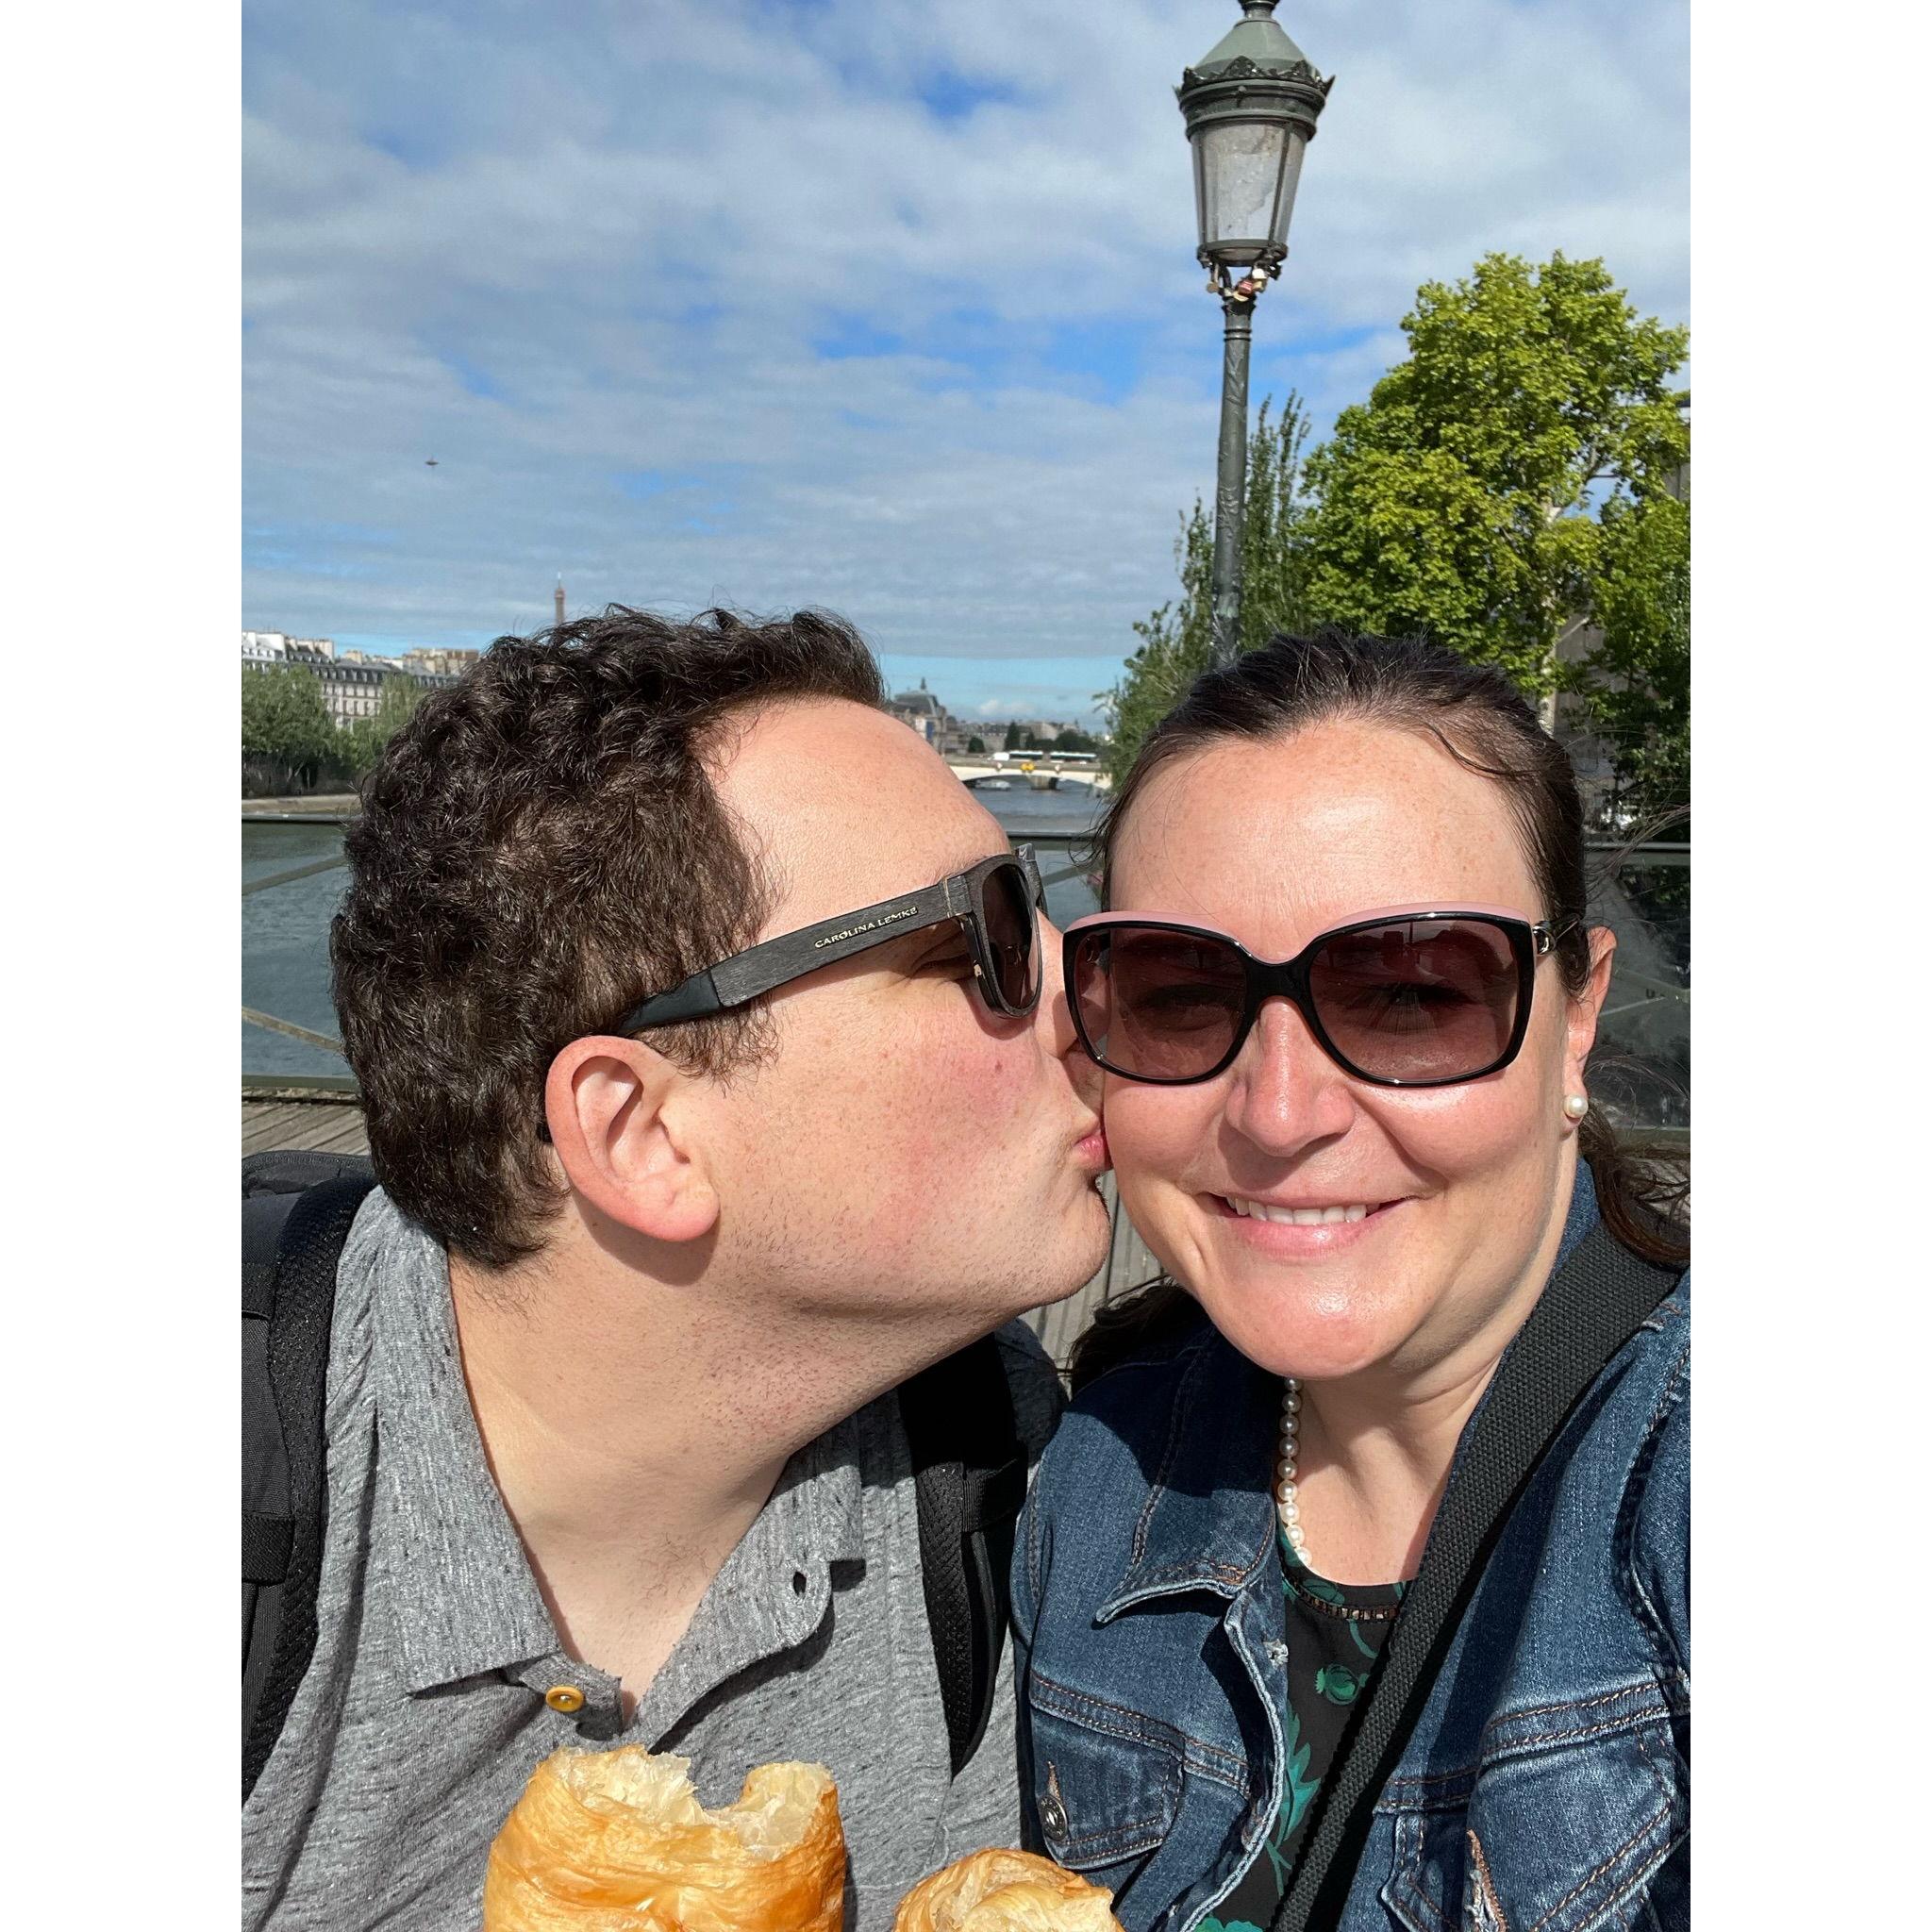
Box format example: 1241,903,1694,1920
1064,908,1557,1086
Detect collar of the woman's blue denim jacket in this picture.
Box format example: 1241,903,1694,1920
1093,1161,1598,1623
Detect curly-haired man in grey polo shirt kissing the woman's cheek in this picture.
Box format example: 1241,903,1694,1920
243,607,1108,1932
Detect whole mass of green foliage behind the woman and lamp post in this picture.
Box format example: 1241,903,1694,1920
1099,253,1690,811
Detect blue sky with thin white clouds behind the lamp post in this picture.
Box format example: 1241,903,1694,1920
243,0,1689,717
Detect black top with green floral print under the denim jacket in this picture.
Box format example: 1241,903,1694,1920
1198,1532,1408,1932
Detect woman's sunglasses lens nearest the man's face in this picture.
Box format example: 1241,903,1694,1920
1069,925,1248,1080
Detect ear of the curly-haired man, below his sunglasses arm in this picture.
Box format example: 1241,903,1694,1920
542,1034,719,1241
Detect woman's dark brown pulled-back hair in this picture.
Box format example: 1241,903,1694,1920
1073,630,1689,1387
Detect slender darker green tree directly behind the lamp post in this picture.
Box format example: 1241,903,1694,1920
1093,391,1307,784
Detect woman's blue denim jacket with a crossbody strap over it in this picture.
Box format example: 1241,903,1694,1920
1012,1167,1690,1932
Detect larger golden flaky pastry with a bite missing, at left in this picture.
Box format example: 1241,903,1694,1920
483,1744,846,1932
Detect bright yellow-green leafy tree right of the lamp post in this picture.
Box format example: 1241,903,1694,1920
1306,253,1689,715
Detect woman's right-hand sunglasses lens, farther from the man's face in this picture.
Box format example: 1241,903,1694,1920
1307,920,1523,1080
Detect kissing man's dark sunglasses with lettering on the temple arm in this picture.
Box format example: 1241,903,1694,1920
608,846,1043,1034
